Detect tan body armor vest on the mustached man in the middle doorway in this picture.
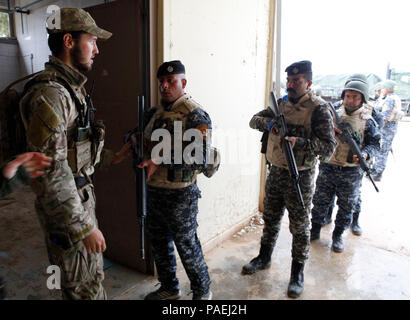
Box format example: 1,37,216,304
266,92,326,171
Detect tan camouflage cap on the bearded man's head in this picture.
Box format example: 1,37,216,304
46,8,112,40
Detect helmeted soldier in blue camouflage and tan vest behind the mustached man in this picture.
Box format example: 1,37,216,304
310,81,380,252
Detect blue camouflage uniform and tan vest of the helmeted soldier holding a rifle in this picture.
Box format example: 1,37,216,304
312,105,380,231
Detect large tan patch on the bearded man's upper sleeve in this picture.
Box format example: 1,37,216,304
27,98,61,147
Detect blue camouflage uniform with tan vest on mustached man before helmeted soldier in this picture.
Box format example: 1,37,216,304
249,92,336,263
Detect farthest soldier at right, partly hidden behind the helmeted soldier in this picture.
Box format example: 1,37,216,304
373,80,401,181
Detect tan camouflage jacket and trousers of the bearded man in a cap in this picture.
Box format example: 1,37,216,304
21,56,114,300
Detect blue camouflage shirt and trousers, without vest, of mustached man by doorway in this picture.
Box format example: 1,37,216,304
249,93,336,263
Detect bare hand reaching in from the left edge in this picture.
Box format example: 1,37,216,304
3,152,53,180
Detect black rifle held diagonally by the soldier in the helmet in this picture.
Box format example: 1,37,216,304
329,102,379,192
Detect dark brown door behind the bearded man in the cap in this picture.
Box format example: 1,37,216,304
85,0,154,274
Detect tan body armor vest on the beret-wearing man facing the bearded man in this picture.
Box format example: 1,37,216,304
144,94,201,189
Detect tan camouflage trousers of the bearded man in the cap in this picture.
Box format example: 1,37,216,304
36,185,107,300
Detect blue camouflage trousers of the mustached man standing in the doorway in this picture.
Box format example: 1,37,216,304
261,166,315,263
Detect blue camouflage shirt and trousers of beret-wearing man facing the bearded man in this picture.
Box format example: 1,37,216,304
144,94,212,294
